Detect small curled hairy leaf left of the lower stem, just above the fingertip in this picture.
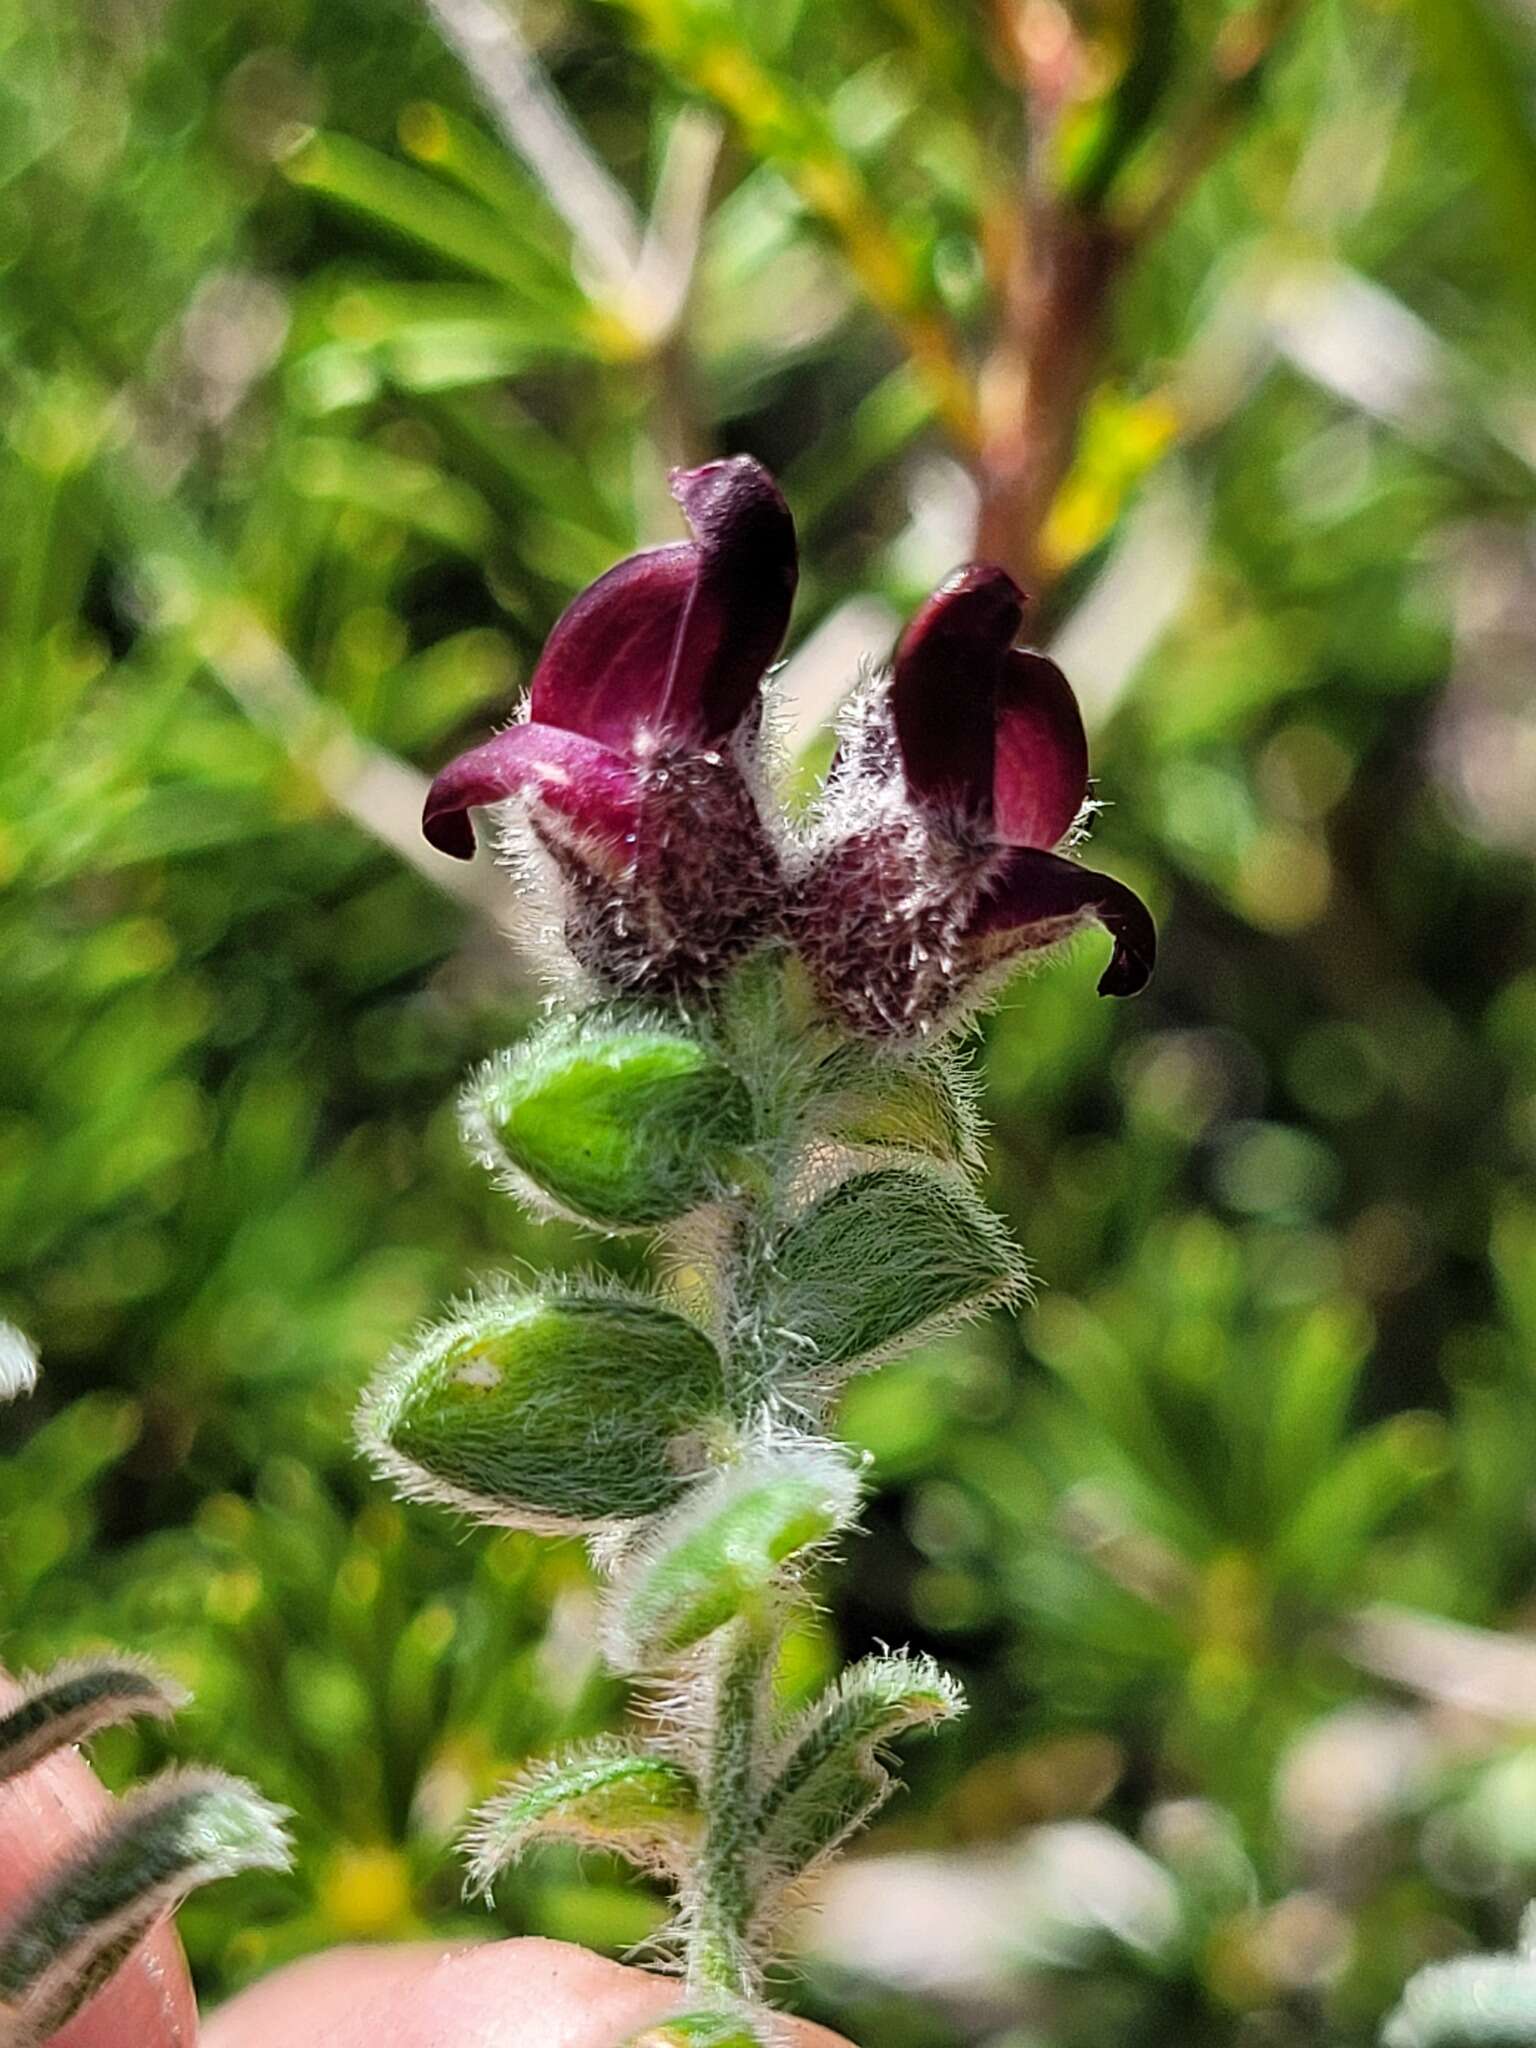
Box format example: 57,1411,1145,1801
465,1739,698,1896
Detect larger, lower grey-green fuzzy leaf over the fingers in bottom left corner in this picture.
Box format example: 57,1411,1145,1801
0,1772,289,2048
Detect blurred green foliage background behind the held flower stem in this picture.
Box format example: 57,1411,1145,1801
0,0,1536,2048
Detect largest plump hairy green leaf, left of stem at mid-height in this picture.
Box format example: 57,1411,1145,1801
370,1282,725,1530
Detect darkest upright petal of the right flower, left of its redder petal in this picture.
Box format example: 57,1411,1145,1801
891,565,1024,831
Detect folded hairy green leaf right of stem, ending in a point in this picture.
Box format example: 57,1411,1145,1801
772,1165,1028,1370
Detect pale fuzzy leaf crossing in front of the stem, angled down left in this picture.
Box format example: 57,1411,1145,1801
606,1444,858,1671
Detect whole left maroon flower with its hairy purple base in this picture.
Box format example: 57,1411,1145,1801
422,455,797,991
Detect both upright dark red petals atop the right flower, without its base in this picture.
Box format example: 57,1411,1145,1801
891,563,1087,848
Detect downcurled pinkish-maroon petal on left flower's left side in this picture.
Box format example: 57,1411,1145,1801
422,725,639,860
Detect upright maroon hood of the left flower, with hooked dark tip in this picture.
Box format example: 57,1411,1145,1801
530,455,797,754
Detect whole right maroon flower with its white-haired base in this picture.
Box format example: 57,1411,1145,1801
795,567,1157,1038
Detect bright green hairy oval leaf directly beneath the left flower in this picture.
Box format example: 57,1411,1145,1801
463,1016,752,1231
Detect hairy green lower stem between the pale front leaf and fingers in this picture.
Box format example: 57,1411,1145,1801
688,1610,778,1999
